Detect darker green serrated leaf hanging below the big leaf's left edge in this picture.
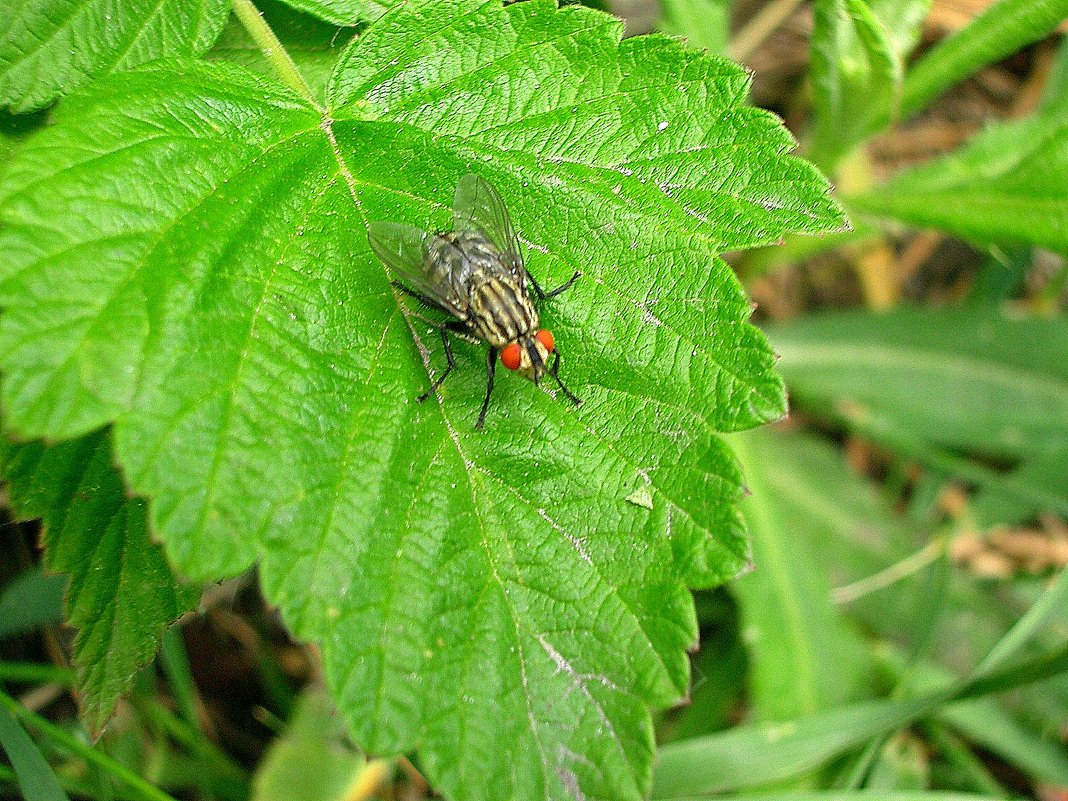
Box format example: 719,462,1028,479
0,433,198,732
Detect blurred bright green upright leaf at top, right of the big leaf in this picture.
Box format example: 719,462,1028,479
811,0,930,170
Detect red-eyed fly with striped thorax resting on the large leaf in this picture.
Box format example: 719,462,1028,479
367,174,582,428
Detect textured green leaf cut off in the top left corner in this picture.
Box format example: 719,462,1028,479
0,0,230,112
